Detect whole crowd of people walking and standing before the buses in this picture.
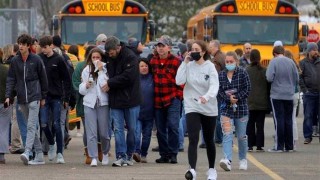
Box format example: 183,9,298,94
0,34,320,180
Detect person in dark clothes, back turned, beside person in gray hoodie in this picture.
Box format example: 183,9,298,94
246,49,269,152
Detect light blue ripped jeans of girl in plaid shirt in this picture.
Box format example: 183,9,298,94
220,116,248,162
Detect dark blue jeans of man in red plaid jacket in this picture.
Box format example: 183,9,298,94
156,98,181,157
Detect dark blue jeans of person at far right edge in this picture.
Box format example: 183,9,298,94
303,92,319,138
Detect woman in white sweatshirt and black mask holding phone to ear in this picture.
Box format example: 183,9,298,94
176,41,219,180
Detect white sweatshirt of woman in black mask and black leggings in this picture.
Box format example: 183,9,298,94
176,60,219,116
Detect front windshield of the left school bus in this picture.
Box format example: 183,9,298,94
61,17,147,44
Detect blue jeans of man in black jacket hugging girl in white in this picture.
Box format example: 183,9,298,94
110,106,140,160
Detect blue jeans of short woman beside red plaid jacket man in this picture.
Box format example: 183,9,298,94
136,119,153,157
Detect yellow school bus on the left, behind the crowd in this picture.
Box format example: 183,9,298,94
52,0,155,57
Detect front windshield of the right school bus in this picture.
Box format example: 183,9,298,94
216,16,298,45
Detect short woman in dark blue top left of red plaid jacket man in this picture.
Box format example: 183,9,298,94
133,58,154,163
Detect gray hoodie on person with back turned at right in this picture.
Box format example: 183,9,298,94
266,55,299,100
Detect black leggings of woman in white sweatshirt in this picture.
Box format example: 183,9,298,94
186,112,217,169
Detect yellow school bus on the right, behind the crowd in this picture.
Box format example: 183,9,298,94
187,0,300,66
